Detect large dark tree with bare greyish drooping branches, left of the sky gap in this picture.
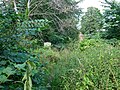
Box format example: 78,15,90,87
29,0,82,44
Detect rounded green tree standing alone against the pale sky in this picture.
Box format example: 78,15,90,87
80,7,103,34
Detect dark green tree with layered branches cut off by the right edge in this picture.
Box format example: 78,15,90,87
103,0,120,39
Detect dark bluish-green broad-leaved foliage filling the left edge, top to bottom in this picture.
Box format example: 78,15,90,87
0,0,49,90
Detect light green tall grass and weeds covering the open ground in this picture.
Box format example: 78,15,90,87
31,39,120,90
